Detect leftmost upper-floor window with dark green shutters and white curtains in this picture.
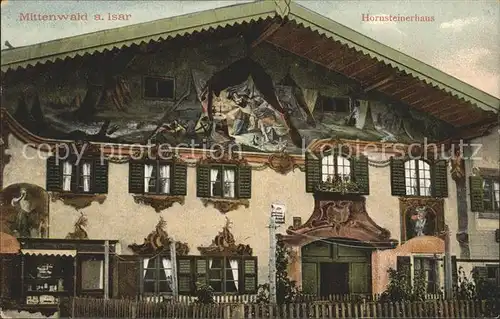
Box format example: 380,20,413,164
47,157,108,193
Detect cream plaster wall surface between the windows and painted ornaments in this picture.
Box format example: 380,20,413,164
4,135,468,283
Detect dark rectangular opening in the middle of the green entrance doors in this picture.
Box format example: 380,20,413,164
320,263,349,297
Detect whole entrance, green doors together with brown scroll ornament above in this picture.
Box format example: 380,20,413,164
281,194,397,295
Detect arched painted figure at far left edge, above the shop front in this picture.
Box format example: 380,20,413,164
0,183,49,238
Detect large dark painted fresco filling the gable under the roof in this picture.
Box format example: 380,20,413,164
2,42,454,152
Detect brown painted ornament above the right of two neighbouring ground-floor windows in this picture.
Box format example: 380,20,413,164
198,218,253,256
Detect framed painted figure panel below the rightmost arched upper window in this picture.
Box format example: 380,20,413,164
399,197,444,242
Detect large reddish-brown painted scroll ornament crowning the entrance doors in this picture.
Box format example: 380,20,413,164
281,195,397,248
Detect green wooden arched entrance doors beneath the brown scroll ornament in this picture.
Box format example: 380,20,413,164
301,238,375,296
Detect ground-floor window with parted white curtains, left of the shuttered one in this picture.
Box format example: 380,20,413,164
141,256,172,295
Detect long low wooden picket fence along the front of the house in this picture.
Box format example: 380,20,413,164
65,298,486,319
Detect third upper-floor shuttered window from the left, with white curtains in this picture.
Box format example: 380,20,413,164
196,165,252,199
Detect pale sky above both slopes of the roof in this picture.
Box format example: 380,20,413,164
1,0,500,98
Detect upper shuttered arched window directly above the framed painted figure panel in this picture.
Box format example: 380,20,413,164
391,157,448,197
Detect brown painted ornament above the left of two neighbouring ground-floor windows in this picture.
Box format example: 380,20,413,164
128,217,189,256
